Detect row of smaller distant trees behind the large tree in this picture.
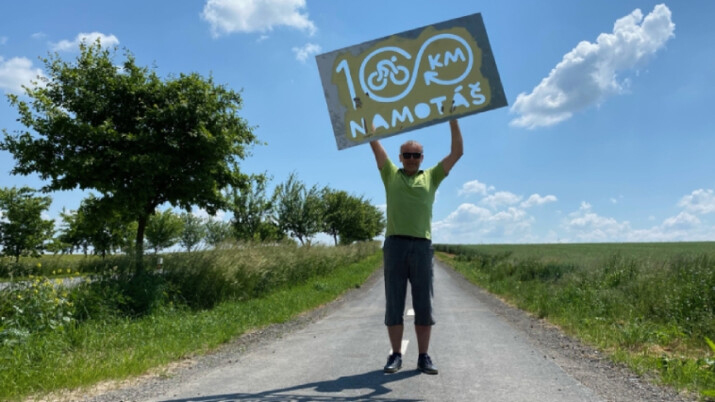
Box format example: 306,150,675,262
0,174,385,260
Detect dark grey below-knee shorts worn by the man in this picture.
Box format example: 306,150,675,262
382,236,435,326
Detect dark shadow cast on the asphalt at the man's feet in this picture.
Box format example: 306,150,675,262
164,370,420,402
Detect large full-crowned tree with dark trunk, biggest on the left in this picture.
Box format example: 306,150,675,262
0,41,257,272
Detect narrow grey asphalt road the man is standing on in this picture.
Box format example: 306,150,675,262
143,261,601,402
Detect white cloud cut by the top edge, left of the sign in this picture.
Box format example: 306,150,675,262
201,0,317,37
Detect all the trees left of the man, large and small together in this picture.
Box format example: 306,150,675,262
0,41,381,273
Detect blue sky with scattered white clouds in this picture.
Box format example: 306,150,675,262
0,0,715,243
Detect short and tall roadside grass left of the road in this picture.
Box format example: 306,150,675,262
0,244,382,400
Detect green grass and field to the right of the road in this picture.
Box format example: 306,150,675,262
435,243,715,397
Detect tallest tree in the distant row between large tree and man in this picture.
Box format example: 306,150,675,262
275,173,323,245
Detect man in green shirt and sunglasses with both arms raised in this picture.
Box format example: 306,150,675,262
370,120,463,374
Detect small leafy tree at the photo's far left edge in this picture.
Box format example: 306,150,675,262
0,187,54,262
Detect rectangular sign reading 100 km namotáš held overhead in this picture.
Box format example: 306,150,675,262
316,14,507,149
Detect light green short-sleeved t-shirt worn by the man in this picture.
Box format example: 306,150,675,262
380,159,447,239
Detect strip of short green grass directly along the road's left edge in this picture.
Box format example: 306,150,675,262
0,252,382,400
